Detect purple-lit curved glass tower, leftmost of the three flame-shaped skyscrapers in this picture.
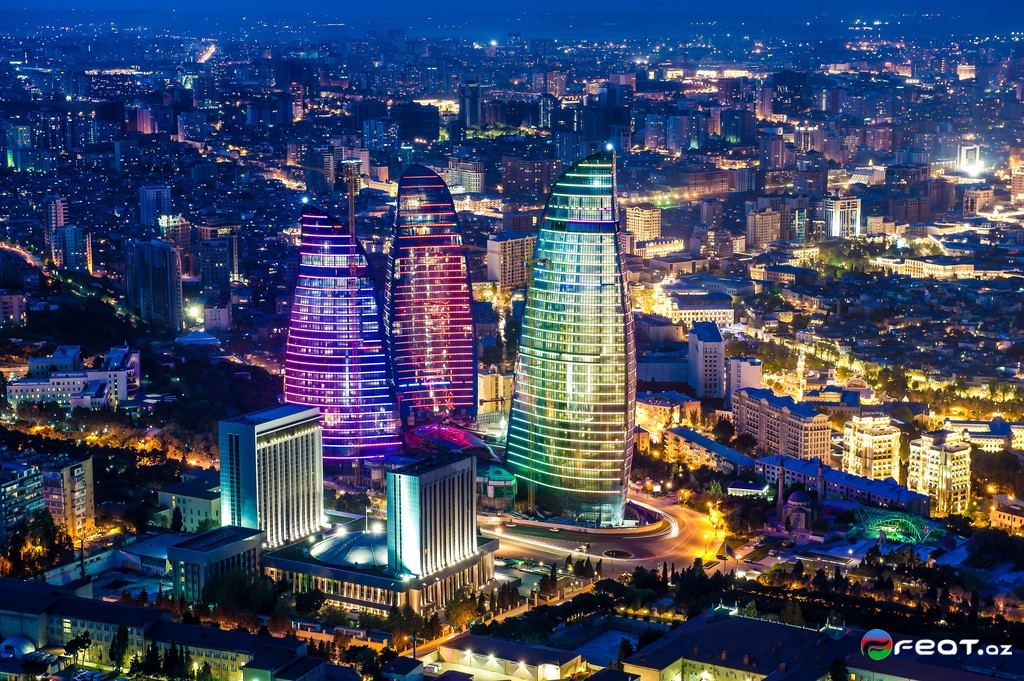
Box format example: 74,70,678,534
285,206,398,465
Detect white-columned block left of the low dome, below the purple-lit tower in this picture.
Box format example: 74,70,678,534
218,405,324,547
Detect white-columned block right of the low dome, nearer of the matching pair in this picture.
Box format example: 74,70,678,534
385,455,476,578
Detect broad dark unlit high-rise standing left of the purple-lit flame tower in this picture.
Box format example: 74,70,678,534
125,239,184,333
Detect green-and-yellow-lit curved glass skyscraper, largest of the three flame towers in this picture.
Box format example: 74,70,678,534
506,152,636,525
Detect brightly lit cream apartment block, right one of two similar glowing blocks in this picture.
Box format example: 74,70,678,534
906,430,971,516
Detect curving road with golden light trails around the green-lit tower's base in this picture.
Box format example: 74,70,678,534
480,494,722,576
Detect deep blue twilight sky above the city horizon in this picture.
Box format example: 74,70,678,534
0,0,1024,38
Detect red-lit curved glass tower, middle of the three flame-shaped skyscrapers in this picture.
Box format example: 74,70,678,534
384,166,476,421
